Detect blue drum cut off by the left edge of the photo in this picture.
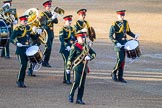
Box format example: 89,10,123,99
0,19,9,48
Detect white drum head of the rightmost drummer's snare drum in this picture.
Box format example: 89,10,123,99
124,40,138,50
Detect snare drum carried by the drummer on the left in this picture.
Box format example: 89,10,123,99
26,45,43,64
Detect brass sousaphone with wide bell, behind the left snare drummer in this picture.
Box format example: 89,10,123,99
24,8,48,44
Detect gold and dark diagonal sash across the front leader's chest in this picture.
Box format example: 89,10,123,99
72,45,89,68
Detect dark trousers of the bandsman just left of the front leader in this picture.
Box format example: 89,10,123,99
61,50,70,81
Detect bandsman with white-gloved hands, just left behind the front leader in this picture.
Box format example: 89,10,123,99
59,15,76,84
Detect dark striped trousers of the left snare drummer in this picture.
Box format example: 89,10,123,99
17,54,28,82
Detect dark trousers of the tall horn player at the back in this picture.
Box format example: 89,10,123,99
44,28,54,63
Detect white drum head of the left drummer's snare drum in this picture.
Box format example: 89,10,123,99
26,46,39,56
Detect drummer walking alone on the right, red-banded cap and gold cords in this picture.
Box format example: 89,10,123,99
109,10,139,83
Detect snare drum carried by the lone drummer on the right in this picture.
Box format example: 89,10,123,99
124,40,141,59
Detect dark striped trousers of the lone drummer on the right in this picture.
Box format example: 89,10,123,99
112,48,125,79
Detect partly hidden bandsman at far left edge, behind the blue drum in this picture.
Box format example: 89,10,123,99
1,0,18,58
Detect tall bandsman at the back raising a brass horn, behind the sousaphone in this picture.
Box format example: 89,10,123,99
41,0,58,67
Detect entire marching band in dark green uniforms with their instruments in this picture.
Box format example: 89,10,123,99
0,0,141,104
